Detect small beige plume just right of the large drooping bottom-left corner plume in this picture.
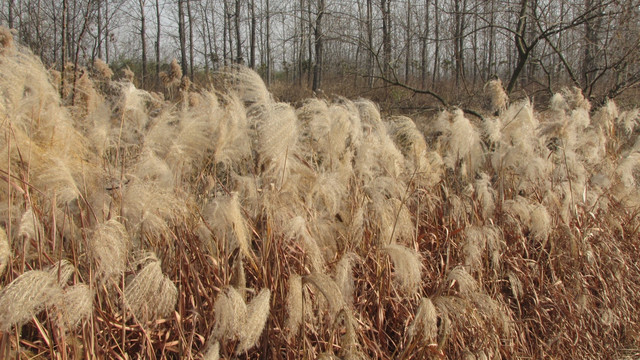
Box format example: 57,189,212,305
56,284,93,329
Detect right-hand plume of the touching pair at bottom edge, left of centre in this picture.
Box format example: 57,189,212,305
236,288,271,355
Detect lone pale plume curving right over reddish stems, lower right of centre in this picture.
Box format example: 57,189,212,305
382,244,422,296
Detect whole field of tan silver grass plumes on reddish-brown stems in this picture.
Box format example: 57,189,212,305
0,26,640,359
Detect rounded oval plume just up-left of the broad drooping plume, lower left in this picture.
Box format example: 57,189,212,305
89,219,131,281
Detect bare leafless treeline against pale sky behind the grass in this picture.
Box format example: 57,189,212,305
0,0,640,103
